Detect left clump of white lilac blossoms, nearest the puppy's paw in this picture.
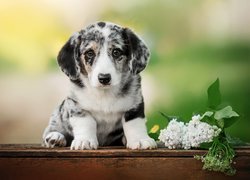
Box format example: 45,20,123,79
159,119,185,149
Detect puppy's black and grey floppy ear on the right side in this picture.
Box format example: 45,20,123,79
124,28,150,74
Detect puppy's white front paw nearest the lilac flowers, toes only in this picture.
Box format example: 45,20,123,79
127,137,157,149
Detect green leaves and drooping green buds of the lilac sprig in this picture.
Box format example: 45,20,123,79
156,79,243,175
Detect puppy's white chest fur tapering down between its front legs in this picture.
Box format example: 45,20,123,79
71,88,133,145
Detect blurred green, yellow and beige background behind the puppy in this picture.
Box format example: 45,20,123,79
0,0,250,143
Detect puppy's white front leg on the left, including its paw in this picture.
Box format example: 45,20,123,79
69,115,98,150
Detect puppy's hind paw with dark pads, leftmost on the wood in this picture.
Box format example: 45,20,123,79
44,132,67,148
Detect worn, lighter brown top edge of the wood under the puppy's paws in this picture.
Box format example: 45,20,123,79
0,144,250,158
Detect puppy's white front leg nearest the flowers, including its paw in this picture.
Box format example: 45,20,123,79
123,117,157,149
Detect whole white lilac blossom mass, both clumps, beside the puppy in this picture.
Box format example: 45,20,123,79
159,115,221,149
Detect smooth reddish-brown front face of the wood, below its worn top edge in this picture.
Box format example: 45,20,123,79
0,157,250,179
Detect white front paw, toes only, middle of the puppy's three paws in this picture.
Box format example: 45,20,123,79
70,138,98,150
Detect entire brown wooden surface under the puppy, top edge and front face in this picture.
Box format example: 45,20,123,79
0,145,250,179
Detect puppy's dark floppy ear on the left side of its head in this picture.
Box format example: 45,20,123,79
57,32,81,80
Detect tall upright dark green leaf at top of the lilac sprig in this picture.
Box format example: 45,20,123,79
207,78,221,109
